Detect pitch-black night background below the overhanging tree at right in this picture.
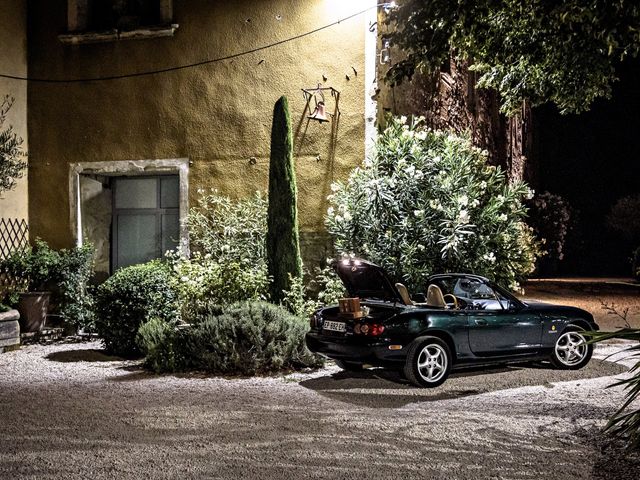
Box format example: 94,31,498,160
535,60,640,276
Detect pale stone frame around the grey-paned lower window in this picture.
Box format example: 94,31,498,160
69,158,190,255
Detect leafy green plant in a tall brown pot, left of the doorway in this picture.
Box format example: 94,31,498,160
2,239,60,332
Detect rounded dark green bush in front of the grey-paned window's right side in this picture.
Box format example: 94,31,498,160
95,261,179,357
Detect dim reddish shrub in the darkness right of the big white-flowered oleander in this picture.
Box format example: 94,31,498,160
527,192,572,260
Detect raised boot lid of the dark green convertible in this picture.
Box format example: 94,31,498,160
332,259,404,303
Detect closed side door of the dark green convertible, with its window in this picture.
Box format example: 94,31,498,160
467,280,542,357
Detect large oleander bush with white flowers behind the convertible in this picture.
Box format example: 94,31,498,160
326,117,538,290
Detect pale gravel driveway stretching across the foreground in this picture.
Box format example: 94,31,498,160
0,343,640,480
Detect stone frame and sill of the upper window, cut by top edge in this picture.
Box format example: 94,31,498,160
58,0,178,45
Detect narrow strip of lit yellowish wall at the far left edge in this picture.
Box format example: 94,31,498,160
0,0,28,219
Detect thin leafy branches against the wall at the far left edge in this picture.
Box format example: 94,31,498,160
0,95,27,193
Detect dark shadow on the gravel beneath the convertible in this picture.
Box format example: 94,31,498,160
300,360,627,408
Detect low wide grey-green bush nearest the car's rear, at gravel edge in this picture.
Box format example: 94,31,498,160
138,301,323,375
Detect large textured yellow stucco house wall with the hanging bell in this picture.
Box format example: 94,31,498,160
28,0,371,253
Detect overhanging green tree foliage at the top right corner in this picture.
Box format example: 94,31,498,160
385,0,640,114
